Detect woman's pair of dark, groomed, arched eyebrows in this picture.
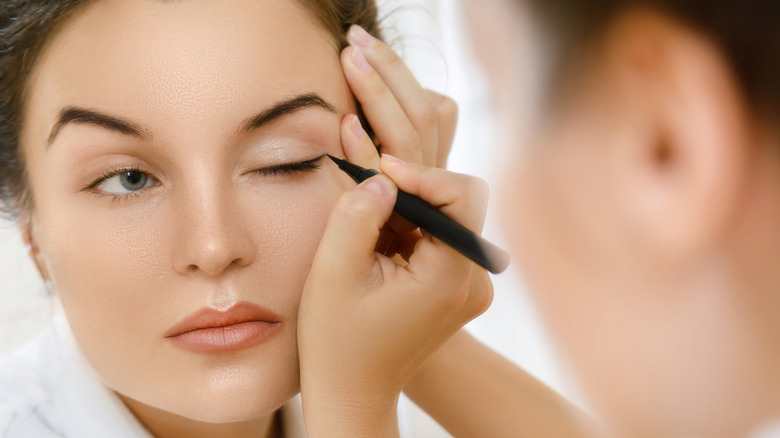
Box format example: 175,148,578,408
48,93,336,146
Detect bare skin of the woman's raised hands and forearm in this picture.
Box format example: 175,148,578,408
298,23,588,437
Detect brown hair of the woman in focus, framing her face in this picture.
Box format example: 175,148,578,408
0,0,381,219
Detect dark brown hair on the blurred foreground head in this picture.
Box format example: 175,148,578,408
526,0,780,115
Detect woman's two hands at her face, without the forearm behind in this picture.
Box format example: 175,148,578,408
298,24,492,436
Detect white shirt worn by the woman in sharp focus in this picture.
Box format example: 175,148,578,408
0,317,306,438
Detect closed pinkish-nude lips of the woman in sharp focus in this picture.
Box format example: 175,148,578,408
164,302,282,353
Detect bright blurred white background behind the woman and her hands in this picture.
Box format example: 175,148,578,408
0,0,577,437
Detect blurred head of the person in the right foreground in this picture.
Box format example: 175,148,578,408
470,0,780,436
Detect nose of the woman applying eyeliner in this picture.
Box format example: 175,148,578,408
173,183,257,276
